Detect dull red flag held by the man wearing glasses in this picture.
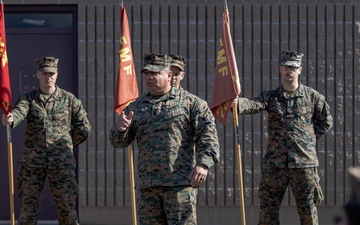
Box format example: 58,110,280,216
210,6,241,124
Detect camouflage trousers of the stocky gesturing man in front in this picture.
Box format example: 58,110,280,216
137,186,197,225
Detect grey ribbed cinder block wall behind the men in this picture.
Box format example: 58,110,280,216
11,0,360,225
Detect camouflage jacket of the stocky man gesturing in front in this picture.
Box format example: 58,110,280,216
110,88,220,189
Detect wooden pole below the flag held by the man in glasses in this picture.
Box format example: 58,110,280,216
232,106,246,225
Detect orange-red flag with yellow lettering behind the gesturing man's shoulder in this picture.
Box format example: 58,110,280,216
114,6,139,114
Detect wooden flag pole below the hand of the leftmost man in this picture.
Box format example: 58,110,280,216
6,125,15,225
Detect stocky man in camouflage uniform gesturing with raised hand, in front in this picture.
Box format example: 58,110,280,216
110,53,219,225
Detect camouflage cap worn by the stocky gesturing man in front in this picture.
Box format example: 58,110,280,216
141,53,171,73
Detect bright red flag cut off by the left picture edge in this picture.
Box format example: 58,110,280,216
0,2,12,115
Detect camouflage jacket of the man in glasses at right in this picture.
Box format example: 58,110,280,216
238,84,333,168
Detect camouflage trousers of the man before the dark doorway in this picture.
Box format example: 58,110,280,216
18,165,78,225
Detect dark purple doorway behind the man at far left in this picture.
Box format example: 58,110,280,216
0,5,77,220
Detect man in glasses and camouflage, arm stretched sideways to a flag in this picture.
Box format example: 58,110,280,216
238,51,333,225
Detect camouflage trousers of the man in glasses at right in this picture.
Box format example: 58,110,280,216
258,167,324,225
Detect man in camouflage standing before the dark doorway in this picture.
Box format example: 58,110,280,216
2,57,91,225
